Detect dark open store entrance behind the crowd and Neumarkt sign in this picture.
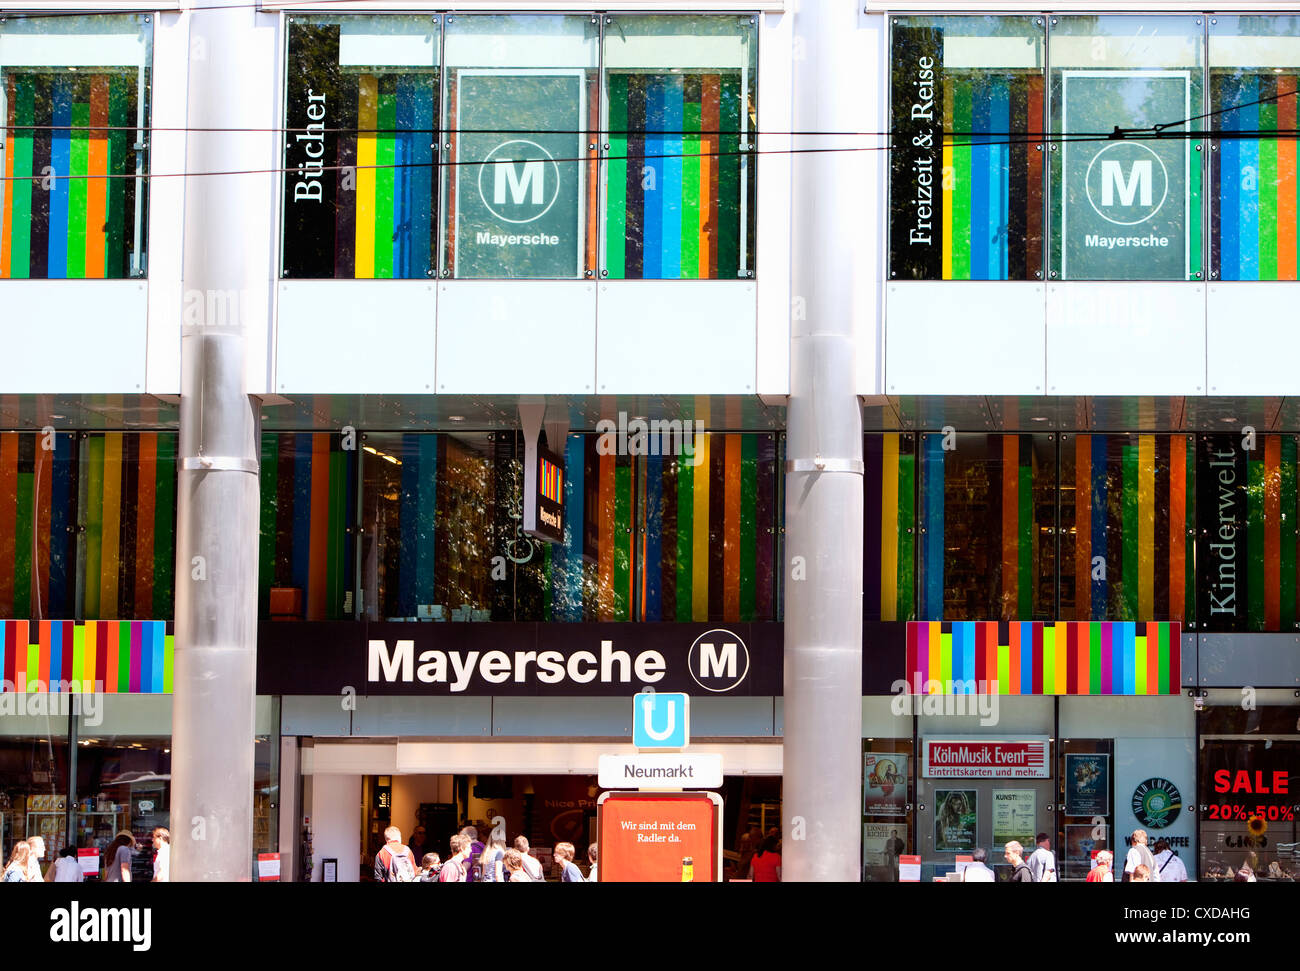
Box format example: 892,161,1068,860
359,775,781,881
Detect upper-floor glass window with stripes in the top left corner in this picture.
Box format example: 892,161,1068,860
0,16,153,279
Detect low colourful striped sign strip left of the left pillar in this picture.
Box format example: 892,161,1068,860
0,620,174,694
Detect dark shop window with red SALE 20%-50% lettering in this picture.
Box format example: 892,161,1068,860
1192,690,1300,883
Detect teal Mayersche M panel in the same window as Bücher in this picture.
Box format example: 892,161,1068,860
454,70,585,278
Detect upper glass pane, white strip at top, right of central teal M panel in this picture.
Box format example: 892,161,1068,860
602,16,758,279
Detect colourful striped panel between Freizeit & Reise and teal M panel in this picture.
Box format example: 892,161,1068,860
943,73,1044,279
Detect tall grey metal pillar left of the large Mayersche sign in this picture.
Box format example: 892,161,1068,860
170,0,263,881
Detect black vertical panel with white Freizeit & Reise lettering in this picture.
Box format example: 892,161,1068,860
889,26,944,279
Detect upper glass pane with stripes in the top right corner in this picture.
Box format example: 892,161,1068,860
1209,14,1300,279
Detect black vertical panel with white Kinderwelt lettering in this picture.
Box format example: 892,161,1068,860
1196,434,1249,630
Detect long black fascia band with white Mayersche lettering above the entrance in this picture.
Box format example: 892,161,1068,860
257,621,905,697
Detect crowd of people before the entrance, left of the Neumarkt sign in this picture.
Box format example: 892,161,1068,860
374,825,598,884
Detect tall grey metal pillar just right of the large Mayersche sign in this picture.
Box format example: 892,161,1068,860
781,0,874,881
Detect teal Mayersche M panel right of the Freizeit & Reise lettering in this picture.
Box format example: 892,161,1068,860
1061,70,1192,279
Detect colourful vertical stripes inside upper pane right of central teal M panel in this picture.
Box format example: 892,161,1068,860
606,71,753,279
